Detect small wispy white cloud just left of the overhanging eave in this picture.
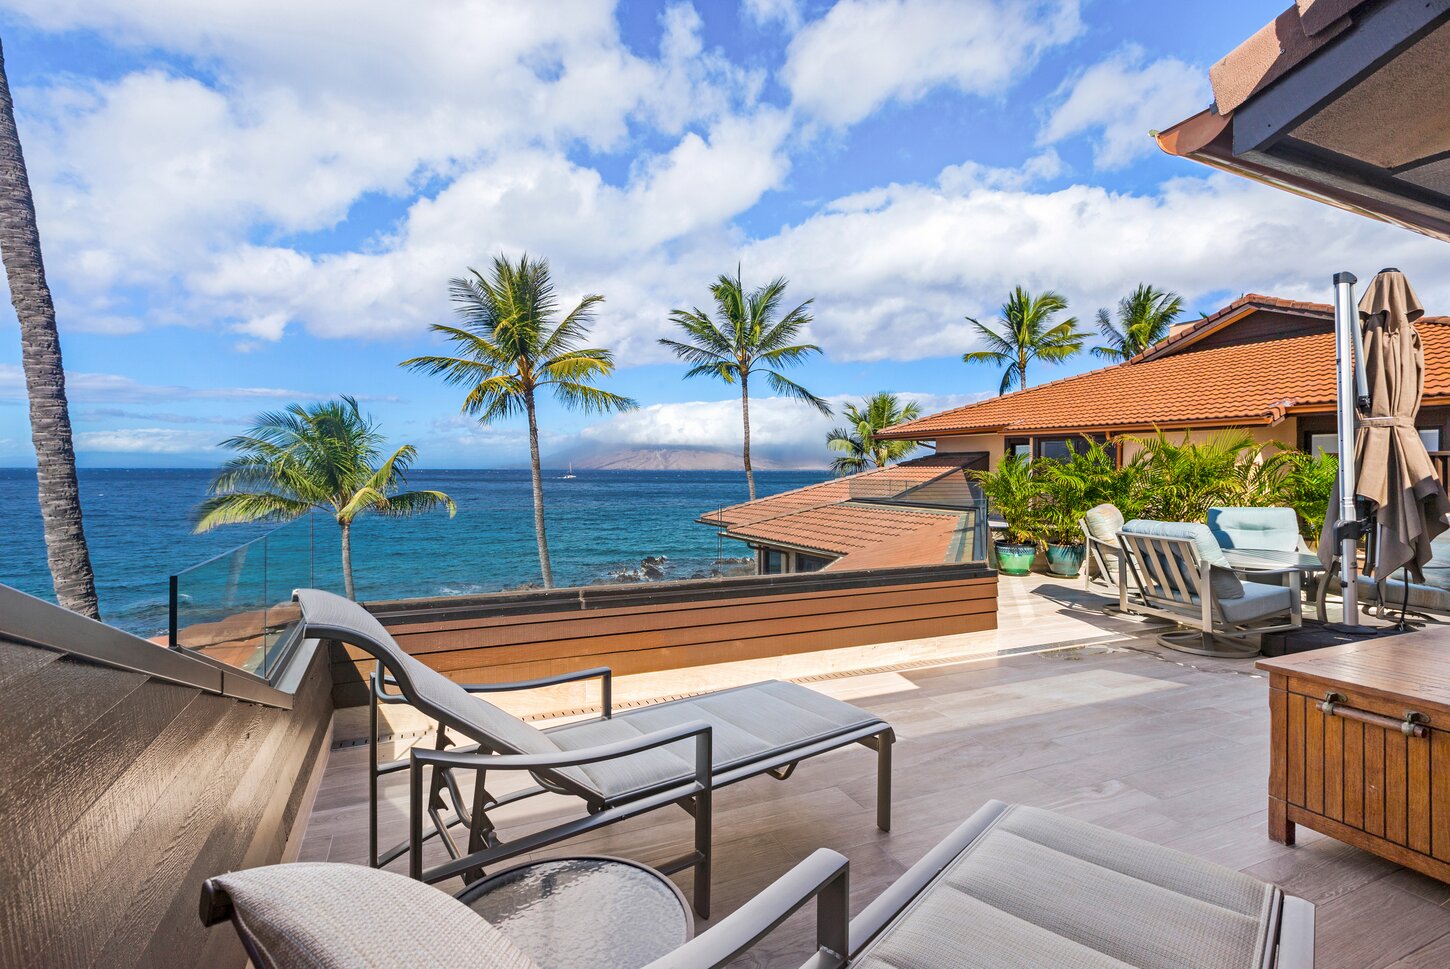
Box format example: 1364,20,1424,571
1038,45,1211,170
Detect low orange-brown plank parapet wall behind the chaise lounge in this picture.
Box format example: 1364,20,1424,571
332,564,996,706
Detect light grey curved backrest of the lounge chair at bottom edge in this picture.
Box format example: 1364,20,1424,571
212,863,538,969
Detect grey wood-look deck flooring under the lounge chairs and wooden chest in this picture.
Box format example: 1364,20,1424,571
302,579,1450,969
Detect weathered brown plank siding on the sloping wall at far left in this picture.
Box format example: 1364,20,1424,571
0,638,332,969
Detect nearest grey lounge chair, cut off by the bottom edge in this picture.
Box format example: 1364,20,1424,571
202,801,1314,969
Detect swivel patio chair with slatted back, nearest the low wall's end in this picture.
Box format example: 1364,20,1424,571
1118,519,1304,657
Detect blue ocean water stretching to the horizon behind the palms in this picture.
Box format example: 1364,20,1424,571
0,469,825,635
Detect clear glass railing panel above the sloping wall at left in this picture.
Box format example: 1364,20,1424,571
171,514,326,677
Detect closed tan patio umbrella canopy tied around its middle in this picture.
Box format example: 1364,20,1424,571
1354,270,1450,582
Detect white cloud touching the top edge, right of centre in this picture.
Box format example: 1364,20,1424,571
783,0,1082,125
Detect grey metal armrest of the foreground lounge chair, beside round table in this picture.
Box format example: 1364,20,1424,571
645,849,851,969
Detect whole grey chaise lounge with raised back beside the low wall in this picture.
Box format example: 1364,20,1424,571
296,589,896,918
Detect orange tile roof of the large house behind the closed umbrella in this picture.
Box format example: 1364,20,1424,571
880,306,1450,440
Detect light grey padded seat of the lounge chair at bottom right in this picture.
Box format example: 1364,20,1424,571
853,807,1275,969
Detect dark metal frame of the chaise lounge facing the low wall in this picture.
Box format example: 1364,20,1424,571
294,589,896,918
